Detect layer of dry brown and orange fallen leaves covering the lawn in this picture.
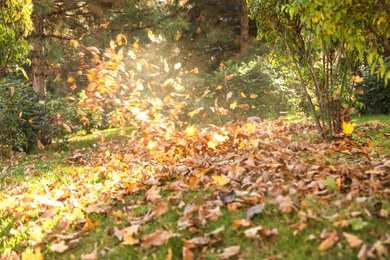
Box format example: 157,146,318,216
0,119,390,259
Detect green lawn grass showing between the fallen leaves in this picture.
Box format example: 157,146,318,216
0,116,390,260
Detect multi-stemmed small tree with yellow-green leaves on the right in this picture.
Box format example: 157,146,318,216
248,0,390,137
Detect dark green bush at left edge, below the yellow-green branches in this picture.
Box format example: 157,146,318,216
0,78,46,155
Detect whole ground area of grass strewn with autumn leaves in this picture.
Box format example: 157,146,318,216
0,118,390,259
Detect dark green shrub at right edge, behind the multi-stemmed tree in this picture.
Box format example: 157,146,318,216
357,57,390,114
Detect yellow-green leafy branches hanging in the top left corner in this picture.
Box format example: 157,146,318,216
0,0,33,81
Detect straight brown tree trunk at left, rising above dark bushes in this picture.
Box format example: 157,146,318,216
31,15,47,97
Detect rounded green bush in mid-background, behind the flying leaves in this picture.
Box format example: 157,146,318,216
183,57,301,123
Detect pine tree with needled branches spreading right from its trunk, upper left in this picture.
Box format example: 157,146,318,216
29,0,160,96
